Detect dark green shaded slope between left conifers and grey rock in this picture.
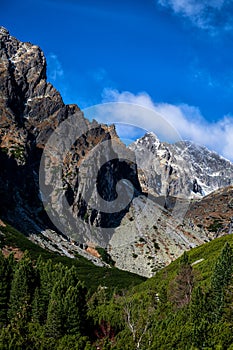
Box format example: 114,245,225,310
0,225,145,290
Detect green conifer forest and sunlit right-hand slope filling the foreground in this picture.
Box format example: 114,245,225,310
0,226,233,350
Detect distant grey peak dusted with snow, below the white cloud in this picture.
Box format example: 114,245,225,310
129,133,233,198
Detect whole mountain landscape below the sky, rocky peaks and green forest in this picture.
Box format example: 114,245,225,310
0,27,233,350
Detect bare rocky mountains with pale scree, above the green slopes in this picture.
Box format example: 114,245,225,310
0,27,233,277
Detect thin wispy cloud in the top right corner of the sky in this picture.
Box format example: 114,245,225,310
157,0,232,34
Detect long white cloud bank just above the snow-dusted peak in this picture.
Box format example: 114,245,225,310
102,89,233,160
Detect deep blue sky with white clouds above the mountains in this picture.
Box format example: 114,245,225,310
0,0,233,159
